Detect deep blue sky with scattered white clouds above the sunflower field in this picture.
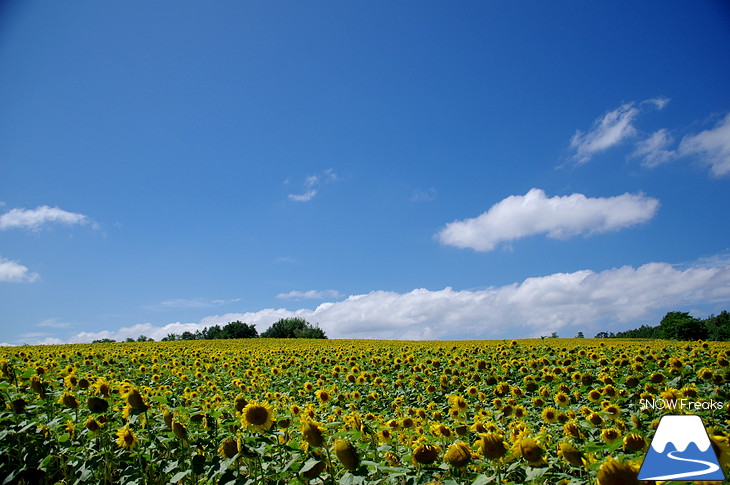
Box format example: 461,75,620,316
0,1,730,345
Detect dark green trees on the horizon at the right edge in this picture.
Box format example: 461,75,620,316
596,310,730,342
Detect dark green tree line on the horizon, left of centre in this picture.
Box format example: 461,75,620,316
93,317,327,343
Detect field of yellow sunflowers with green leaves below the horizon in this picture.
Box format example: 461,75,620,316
0,339,730,485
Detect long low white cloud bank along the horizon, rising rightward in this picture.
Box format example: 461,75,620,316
59,259,730,342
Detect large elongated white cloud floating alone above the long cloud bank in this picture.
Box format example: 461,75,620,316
436,189,659,251
